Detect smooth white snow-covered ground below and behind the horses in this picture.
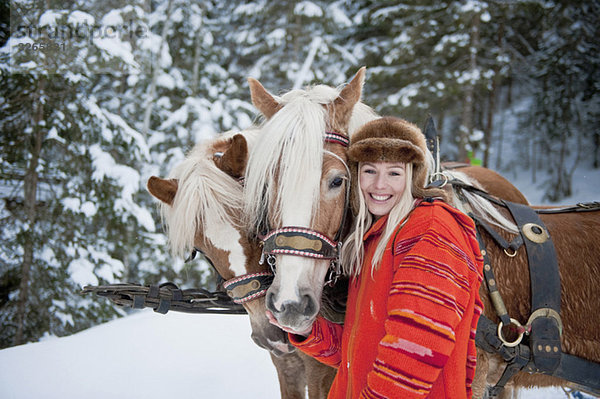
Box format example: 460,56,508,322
0,164,600,399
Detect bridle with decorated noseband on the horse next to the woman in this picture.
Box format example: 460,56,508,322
259,132,351,286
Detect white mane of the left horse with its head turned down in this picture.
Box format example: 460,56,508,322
161,130,257,256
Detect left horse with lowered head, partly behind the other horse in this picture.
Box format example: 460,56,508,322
147,129,335,399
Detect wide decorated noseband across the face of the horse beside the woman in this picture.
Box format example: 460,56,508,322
263,226,338,259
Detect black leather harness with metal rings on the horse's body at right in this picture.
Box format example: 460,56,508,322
448,180,600,397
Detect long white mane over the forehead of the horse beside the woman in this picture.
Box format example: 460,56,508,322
244,85,377,232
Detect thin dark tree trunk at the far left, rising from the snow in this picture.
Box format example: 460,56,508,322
14,78,46,345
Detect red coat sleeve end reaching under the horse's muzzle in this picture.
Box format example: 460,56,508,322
288,316,343,368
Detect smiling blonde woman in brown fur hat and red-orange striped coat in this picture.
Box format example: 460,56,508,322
290,117,483,399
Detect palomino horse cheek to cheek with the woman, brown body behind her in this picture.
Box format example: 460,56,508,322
244,69,600,397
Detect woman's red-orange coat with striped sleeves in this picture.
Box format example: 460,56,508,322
290,201,483,399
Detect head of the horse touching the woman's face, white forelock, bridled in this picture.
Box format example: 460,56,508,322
244,68,375,331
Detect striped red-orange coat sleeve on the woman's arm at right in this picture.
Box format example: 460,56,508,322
361,212,479,398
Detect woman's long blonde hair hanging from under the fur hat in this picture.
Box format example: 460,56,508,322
341,163,414,276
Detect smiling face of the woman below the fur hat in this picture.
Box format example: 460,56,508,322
358,162,406,217
